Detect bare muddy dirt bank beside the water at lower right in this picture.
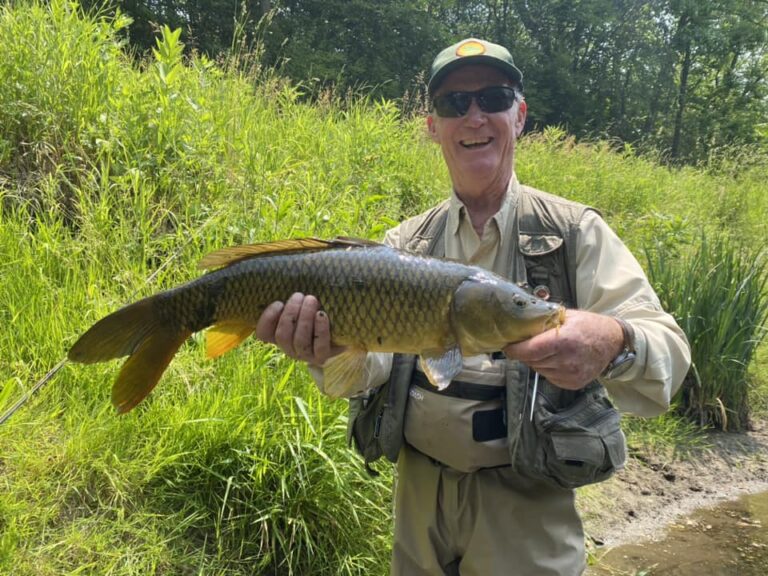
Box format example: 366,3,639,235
578,421,768,550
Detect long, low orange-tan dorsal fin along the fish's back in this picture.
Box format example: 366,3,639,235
197,237,381,269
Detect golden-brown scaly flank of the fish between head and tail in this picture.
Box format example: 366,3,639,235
198,248,466,349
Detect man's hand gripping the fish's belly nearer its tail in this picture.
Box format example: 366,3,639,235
256,292,344,366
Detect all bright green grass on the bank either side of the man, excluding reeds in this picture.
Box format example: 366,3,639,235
0,0,768,576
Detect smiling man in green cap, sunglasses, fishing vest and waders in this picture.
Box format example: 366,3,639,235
257,39,690,576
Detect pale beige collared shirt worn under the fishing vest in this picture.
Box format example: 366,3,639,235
312,177,690,416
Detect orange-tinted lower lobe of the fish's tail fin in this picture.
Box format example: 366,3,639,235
112,327,192,414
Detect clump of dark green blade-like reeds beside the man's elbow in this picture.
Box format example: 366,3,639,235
646,235,768,430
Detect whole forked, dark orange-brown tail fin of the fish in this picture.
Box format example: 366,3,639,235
68,297,191,414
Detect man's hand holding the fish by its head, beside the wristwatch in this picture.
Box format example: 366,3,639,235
504,310,624,390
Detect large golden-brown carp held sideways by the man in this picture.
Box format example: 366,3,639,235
67,237,565,413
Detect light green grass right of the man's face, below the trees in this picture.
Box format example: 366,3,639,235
517,127,768,254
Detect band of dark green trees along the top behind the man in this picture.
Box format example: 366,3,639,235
81,0,768,162
